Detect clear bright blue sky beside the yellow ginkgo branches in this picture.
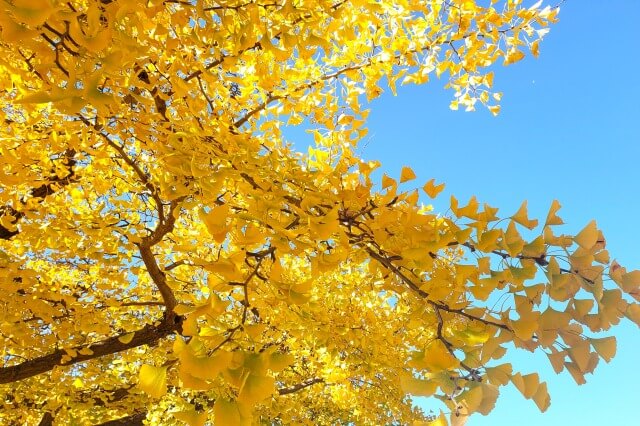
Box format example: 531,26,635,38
360,0,640,426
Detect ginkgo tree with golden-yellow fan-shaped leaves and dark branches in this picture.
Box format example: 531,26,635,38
0,0,640,425
